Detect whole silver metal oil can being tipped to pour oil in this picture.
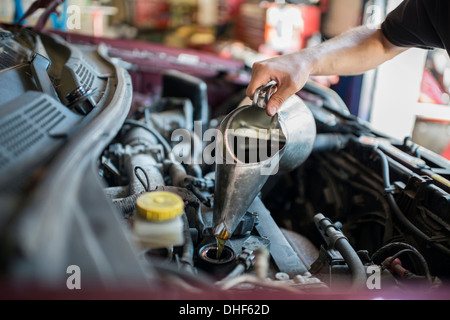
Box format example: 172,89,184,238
213,91,316,238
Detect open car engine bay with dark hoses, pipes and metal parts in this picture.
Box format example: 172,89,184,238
0,25,450,299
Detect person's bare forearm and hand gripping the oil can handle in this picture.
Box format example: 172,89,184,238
247,27,406,115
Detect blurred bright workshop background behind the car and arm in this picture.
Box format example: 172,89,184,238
0,0,450,159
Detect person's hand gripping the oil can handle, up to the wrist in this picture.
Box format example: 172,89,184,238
247,51,312,116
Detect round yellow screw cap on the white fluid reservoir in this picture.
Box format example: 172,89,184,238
136,191,184,221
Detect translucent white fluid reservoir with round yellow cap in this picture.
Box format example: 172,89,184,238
133,191,184,248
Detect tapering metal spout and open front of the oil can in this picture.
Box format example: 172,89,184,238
214,106,284,238
